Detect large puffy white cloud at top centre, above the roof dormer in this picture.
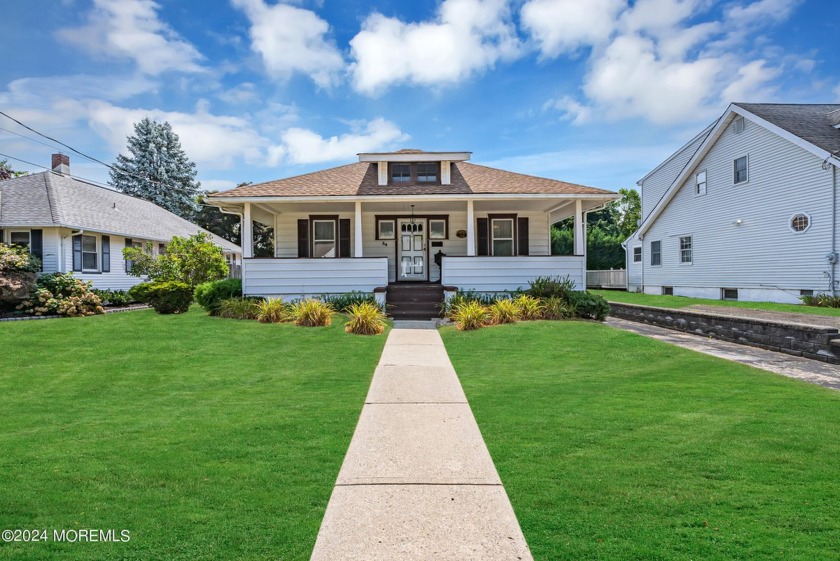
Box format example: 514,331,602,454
350,0,520,95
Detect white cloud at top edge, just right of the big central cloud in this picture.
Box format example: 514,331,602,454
521,0,625,57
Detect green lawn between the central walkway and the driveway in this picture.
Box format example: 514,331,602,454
442,322,840,561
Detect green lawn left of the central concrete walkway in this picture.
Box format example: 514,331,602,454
0,308,385,561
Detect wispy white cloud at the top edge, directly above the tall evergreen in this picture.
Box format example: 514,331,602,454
57,0,204,76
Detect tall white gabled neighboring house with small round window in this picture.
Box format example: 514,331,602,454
626,103,840,303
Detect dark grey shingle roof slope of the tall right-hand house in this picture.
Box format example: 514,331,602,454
735,103,840,153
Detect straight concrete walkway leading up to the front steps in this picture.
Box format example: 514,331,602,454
312,322,532,561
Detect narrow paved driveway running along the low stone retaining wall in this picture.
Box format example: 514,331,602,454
606,317,840,390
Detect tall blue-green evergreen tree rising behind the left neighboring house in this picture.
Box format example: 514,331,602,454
110,117,200,220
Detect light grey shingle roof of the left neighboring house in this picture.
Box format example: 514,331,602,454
0,171,241,252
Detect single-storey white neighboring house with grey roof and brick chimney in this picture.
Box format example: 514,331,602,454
0,154,242,290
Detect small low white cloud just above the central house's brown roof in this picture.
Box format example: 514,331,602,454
283,117,409,164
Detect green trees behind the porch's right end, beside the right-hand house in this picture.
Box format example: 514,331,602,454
551,189,641,270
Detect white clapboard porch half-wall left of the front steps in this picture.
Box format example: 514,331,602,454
242,257,388,297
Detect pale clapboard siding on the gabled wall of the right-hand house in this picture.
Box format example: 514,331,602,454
627,113,833,301
